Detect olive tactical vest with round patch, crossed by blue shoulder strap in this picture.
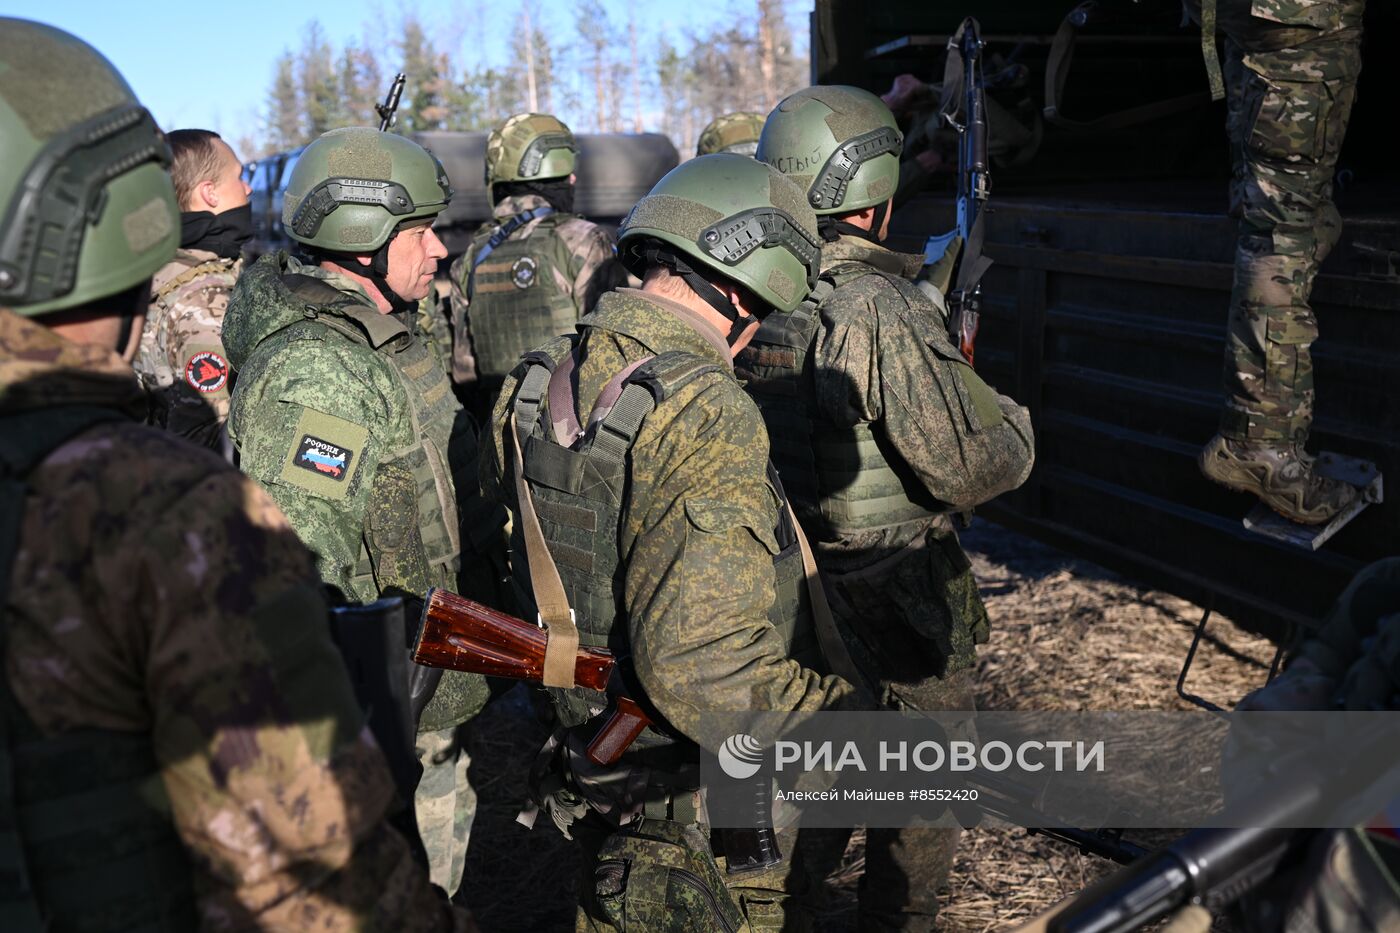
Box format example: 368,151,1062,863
466,212,580,385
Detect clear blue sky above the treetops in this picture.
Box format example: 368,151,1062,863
0,0,812,140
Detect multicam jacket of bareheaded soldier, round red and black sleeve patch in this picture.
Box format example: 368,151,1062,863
133,249,242,448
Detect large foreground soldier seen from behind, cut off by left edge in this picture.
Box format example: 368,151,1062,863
0,17,465,933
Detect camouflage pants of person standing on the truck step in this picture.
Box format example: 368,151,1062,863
1218,0,1365,443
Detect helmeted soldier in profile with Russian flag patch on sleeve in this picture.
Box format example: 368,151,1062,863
224,127,504,892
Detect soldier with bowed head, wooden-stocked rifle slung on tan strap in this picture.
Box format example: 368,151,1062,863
482,154,861,932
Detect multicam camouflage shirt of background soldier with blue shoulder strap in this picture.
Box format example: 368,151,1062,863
448,195,627,389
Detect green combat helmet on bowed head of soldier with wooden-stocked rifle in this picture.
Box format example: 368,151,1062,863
617,153,822,343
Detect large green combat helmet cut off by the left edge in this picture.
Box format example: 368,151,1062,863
0,17,179,317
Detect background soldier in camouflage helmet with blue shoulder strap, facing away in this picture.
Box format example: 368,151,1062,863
449,113,627,415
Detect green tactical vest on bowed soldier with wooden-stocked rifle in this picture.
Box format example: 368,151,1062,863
512,336,826,749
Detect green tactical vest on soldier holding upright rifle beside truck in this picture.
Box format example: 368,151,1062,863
735,263,938,541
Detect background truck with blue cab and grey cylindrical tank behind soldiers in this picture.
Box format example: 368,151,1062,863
244,132,680,256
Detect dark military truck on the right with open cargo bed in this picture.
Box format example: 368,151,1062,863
812,0,1400,669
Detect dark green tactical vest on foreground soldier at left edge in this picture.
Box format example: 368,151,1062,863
0,408,197,933
